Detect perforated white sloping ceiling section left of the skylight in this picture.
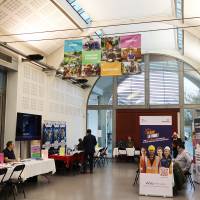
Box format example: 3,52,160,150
0,0,80,55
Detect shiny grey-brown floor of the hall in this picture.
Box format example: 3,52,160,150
5,163,200,200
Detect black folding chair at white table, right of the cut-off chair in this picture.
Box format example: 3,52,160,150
8,164,26,200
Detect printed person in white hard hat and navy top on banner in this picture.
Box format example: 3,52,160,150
160,146,172,174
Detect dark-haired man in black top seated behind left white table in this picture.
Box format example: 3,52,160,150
3,141,16,163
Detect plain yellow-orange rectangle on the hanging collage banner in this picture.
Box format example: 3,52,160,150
101,61,122,76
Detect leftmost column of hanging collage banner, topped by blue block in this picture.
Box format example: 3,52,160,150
63,39,83,78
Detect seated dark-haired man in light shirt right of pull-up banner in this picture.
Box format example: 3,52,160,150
175,141,192,174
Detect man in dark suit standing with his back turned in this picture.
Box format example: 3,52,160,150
83,129,97,173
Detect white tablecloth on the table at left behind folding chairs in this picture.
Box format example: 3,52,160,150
1,159,56,181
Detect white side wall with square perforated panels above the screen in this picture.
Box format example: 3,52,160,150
17,63,86,150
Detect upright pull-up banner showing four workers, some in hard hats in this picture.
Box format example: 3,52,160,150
139,116,173,197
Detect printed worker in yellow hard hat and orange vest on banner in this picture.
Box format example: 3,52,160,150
146,145,160,174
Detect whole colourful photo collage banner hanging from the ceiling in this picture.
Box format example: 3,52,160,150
61,34,142,78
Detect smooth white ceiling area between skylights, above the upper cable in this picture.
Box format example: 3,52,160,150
77,0,172,21
